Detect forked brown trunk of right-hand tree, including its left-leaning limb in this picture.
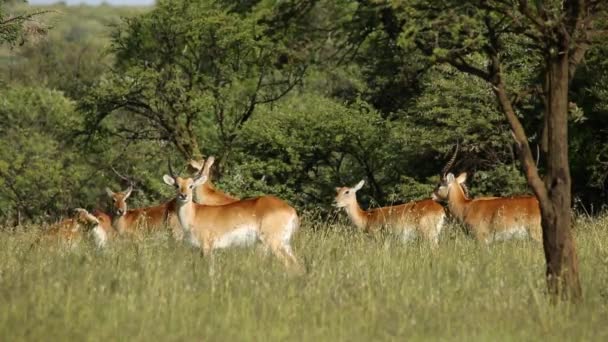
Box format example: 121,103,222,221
490,46,582,301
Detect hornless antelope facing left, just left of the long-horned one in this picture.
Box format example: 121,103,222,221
334,180,445,247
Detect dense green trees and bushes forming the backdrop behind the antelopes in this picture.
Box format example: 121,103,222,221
0,0,608,223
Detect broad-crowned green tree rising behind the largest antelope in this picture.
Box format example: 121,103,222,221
81,0,306,160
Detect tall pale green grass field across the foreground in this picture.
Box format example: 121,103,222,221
0,216,608,341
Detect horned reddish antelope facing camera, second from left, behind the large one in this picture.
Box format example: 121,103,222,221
106,185,181,240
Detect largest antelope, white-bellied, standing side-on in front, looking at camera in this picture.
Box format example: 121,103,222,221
163,157,303,272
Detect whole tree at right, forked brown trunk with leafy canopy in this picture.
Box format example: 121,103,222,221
393,0,608,300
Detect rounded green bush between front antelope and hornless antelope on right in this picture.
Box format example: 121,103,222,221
224,93,394,211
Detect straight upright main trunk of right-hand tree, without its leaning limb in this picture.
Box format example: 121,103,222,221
541,44,582,300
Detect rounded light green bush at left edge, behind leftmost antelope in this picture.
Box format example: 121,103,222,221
0,86,89,225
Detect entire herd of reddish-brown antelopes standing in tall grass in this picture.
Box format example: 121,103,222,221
37,146,542,271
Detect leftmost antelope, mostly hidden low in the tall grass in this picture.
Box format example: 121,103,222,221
32,208,113,248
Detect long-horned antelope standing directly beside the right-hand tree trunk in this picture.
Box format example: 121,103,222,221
433,147,542,244
